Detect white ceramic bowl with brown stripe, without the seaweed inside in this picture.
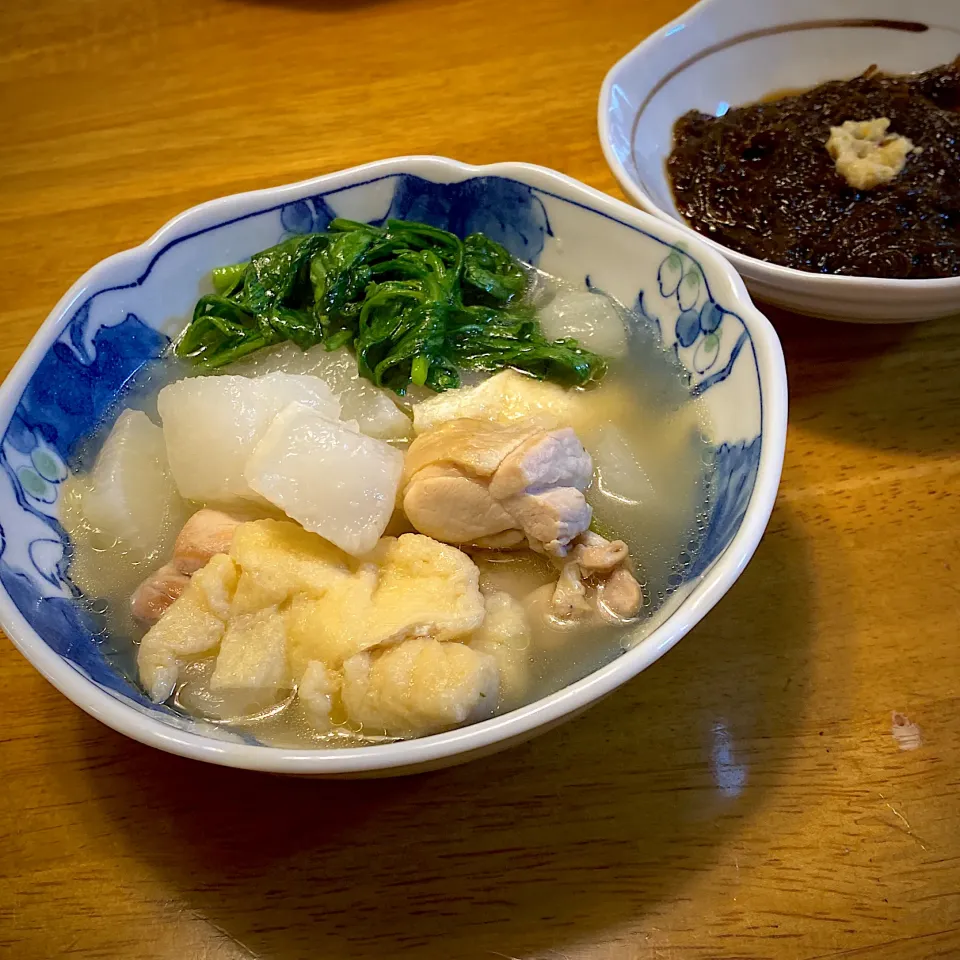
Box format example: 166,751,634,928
598,0,960,323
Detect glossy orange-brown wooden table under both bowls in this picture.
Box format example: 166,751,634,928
0,0,960,960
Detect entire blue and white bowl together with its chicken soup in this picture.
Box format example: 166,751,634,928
0,157,787,776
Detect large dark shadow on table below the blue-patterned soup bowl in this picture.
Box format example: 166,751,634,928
69,507,811,960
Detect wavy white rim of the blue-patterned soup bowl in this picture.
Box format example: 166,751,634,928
0,156,787,776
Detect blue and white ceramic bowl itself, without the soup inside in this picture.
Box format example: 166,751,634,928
0,157,787,776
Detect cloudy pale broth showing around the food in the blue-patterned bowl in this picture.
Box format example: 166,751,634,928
63,275,712,747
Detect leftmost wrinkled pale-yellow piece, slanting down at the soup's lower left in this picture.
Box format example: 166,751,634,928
137,554,237,703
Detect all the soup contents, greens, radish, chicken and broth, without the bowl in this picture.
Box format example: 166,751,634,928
64,220,710,746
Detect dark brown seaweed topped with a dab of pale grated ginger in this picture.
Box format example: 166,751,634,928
667,60,960,279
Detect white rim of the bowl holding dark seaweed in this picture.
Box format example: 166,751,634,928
597,0,960,295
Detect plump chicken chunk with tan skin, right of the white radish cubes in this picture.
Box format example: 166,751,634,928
403,419,593,557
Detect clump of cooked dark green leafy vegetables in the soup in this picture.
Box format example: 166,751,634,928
176,219,606,396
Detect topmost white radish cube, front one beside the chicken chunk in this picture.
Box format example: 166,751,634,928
244,403,403,556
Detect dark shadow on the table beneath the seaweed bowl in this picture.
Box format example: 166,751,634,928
758,303,960,455
